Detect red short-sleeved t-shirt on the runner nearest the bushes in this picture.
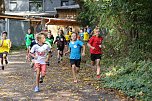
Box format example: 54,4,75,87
88,36,103,54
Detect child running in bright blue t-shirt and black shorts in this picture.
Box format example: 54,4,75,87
65,33,85,83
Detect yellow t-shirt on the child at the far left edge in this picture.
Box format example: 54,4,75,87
0,39,11,53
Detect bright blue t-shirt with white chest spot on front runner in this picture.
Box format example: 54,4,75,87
69,40,83,59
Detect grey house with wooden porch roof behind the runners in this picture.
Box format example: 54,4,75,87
0,0,78,45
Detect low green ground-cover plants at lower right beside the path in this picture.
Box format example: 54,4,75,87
102,59,152,101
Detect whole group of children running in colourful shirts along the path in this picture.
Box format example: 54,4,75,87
0,27,103,92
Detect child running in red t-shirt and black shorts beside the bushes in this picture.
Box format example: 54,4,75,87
87,28,103,79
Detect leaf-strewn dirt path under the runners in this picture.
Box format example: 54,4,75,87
0,51,120,101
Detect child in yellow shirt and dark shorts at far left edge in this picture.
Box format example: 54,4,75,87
0,32,11,70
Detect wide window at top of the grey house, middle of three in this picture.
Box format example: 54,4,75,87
29,0,43,11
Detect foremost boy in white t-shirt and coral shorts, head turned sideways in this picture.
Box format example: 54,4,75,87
30,32,51,92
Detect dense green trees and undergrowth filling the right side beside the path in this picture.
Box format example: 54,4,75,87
78,0,152,101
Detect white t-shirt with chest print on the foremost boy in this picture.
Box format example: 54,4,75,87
30,44,51,64
